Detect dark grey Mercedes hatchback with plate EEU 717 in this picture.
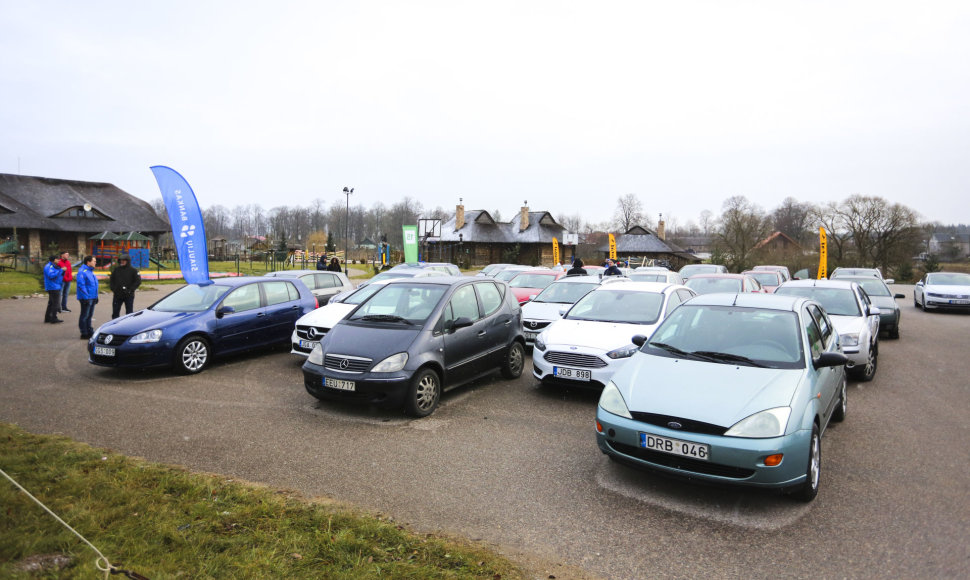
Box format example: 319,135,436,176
303,277,525,417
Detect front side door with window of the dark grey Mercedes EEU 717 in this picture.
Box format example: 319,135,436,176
442,284,488,383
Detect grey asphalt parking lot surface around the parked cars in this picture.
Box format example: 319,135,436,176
0,285,970,578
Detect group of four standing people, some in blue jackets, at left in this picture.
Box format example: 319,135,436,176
44,252,141,339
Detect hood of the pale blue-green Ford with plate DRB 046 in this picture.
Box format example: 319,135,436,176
613,352,804,427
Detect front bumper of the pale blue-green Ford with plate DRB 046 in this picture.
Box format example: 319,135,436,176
596,407,811,489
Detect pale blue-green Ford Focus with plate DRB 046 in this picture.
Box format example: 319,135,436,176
596,294,847,501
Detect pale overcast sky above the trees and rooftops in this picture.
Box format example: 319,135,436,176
0,0,970,229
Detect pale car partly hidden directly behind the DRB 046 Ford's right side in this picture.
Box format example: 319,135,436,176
775,280,880,381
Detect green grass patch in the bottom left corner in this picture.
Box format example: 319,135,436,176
0,423,523,580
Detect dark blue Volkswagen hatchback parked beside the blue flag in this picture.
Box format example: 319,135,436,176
88,277,317,374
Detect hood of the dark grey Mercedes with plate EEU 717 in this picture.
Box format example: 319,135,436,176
321,320,422,362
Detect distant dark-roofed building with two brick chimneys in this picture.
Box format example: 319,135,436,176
430,204,573,266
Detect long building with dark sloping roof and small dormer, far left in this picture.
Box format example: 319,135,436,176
0,173,169,261
